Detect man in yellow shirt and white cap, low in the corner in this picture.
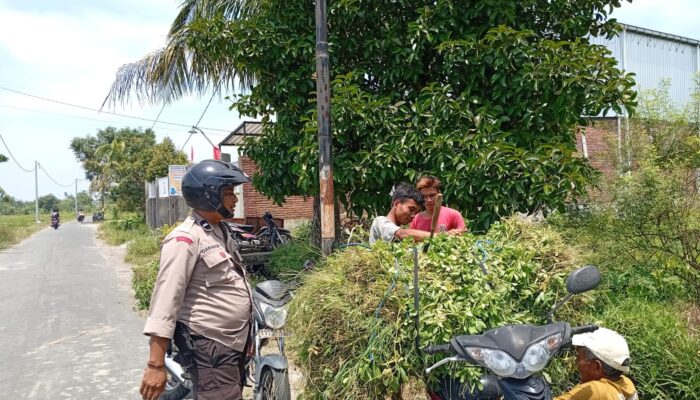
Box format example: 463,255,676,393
555,328,639,400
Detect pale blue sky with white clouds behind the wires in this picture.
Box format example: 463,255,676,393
0,0,700,200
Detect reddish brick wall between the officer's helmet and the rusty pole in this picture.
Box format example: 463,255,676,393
238,156,314,228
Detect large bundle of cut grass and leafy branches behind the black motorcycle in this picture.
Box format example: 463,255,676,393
289,218,580,399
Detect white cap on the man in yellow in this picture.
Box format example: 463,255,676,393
571,328,630,373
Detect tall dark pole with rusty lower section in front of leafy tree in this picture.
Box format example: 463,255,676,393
316,0,335,254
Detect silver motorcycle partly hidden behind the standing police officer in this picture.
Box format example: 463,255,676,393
160,280,292,400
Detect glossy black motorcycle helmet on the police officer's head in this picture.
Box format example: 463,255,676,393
182,160,250,218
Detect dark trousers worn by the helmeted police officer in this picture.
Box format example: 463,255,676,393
175,324,245,400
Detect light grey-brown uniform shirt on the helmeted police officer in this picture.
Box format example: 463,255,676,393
143,212,252,351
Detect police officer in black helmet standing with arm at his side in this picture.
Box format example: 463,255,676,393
140,160,252,400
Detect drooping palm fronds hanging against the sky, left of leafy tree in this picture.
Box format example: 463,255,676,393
102,0,261,107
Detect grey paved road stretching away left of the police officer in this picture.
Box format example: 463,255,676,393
0,222,148,400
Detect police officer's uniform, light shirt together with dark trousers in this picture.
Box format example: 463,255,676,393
143,211,252,400
